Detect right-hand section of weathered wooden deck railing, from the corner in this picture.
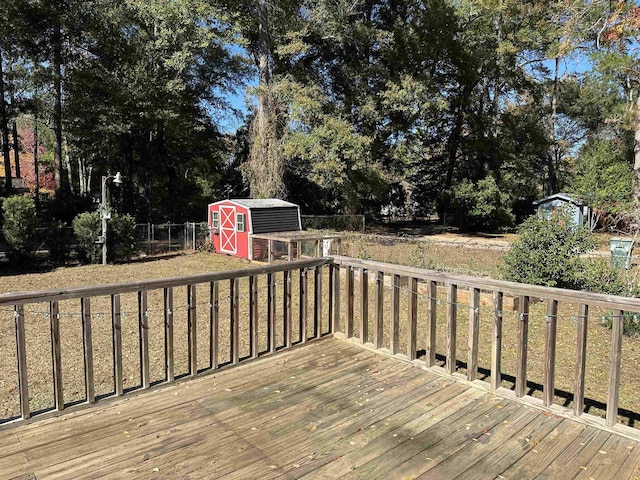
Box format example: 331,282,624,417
332,257,640,434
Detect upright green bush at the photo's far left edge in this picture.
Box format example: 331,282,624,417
2,195,38,261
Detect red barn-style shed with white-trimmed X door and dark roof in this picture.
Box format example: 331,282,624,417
209,198,302,259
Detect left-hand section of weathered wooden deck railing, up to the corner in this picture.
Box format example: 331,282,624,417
0,258,332,421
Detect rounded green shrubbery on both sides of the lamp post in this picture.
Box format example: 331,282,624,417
73,212,136,263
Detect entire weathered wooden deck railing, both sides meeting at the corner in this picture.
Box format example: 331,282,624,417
0,256,640,434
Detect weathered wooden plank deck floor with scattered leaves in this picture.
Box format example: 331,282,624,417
0,338,640,480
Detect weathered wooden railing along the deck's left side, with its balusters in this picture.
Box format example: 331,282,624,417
0,258,332,422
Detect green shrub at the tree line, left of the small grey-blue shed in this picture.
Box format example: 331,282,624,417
448,176,515,231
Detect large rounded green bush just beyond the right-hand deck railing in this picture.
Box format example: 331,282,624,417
504,211,597,289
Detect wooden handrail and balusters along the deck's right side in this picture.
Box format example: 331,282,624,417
332,256,640,434
